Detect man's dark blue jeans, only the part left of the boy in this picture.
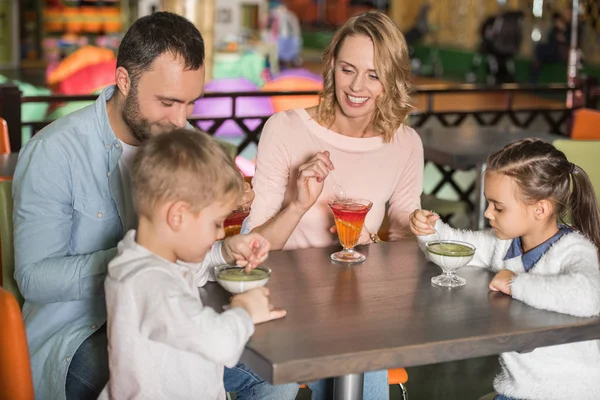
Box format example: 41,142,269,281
65,324,108,400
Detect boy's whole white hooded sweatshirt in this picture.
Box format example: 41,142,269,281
99,231,254,400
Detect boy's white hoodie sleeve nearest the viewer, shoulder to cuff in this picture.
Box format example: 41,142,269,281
131,268,254,367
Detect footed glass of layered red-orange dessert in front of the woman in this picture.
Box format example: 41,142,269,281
328,199,373,263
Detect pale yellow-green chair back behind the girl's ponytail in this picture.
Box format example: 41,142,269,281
553,139,600,206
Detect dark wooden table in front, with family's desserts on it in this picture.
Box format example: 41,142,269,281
200,240,600,399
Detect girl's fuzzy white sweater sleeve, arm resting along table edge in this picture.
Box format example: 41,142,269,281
510,238,600,317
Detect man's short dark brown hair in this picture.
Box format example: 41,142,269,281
117,12,204,82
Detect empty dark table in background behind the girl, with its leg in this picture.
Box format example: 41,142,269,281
419,125,564,229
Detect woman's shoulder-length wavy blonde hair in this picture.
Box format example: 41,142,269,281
316,11,413,143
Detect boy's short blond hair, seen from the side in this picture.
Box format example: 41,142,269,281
131,129,244,217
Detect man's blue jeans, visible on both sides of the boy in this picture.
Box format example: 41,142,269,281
65,324,299,400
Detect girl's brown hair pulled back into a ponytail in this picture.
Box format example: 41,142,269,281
487,139,600,249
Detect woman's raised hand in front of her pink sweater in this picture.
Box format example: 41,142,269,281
292,151,334,212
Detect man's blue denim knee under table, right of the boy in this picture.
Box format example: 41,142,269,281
223,363,300,400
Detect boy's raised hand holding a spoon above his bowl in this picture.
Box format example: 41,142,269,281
221,233,271,271
